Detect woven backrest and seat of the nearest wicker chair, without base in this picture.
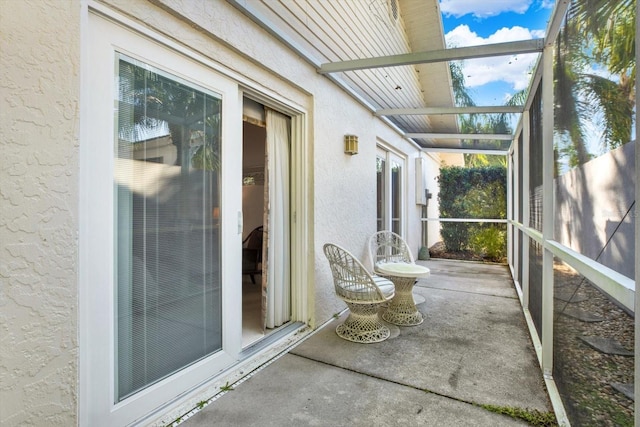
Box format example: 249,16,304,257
323,243,388,302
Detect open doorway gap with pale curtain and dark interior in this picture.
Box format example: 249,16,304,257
242,97,291,348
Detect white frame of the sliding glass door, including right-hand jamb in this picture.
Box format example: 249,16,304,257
78,8,314,425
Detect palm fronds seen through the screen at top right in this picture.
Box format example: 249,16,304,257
554,0,636,162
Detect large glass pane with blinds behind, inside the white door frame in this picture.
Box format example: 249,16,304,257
115,57,222,401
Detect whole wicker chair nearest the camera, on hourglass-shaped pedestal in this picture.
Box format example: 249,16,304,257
323,243,395,343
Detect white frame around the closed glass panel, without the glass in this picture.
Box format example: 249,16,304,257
79,14,241,425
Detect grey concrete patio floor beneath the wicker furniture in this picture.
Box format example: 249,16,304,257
181,259,552,427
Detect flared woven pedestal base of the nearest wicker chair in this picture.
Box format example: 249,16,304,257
336,302,391,343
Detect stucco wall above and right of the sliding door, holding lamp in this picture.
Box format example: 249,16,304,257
104,0,430,324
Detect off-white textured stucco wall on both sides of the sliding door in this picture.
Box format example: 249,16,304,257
0,0,436,426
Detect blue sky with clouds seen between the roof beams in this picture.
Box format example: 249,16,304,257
439,0,554,105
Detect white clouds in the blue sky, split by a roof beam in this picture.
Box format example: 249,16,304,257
445,25,538,91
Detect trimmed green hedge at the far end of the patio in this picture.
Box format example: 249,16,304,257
438,166,507,261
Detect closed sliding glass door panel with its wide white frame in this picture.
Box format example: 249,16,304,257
84,13,242,426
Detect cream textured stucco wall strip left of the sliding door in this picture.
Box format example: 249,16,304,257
0,0,80,426
